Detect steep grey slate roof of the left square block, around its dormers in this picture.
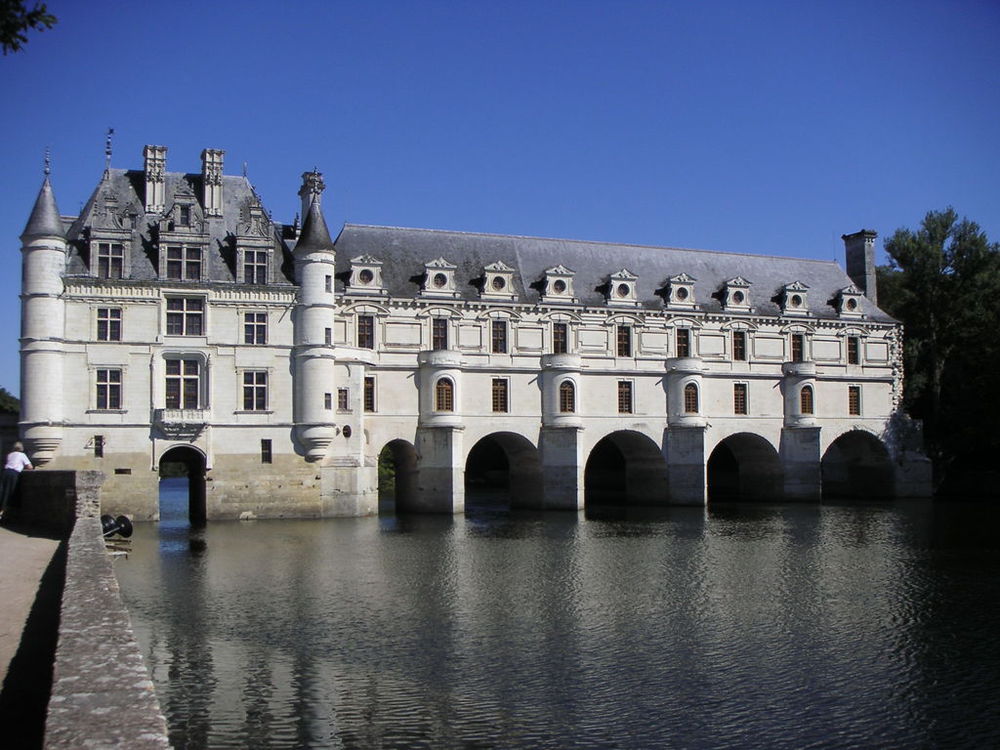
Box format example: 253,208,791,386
67,169,290,284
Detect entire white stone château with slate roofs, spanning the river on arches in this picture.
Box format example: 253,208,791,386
20,146,928,519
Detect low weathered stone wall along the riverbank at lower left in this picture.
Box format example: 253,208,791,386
17,471,170,750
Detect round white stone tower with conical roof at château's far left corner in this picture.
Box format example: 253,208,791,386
20,173,66,465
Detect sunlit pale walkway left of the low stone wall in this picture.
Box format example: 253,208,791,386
0,527,59,685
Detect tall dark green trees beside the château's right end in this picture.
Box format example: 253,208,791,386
879,208,1000,478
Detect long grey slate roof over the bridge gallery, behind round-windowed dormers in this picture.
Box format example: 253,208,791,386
335,224,893,322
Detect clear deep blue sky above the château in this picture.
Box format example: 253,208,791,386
0,0,1000,393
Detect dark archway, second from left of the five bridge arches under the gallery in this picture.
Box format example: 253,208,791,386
465,432,542,511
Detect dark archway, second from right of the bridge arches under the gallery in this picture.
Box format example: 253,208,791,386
707,432,783,502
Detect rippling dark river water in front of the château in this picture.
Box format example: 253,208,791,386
115,484,1000,749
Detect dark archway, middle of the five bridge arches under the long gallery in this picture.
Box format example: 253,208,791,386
583,430,667,505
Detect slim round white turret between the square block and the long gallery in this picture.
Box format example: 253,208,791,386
294,171,336,461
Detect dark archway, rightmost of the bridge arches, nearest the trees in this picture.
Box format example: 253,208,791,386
822,430,894,498
